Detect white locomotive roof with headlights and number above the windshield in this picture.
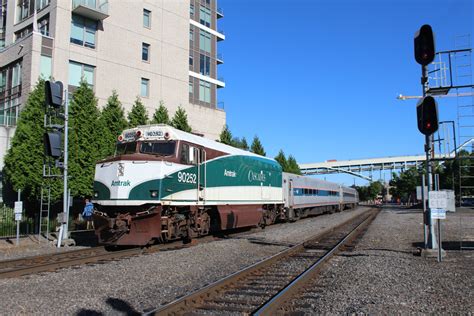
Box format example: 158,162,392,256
121,124,275,161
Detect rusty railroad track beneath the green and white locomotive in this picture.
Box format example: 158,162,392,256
0,225,262,279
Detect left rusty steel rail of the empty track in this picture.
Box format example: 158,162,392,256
143,209,378,315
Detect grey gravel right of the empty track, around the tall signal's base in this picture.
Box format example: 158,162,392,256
284,209,474,315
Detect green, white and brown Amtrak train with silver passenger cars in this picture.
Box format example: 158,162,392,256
93,124,358,245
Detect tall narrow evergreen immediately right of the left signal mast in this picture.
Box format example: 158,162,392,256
68,80,103,197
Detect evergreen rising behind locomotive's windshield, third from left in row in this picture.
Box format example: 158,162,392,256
99,90,127,158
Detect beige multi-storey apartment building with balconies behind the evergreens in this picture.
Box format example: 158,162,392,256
0,0,226,167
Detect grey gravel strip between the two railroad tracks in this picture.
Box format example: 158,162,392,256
0,207,367,315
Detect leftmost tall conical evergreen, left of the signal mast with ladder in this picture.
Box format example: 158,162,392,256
3,79,62,203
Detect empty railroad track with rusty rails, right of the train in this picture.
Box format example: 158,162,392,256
145,210,379,315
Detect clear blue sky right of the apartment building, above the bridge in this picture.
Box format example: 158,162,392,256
218,0,474,183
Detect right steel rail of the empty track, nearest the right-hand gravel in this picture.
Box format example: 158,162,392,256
252,209,377,316
